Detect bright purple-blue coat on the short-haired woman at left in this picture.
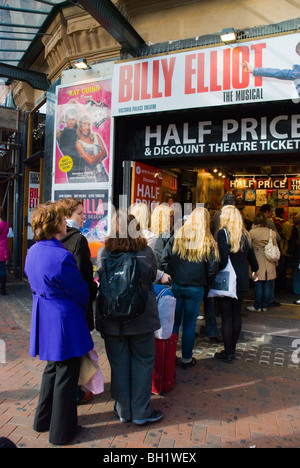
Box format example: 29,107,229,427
25,239,94,361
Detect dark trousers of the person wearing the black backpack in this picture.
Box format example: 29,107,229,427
104,333,155,420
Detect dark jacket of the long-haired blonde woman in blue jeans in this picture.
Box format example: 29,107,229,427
162,236,219,287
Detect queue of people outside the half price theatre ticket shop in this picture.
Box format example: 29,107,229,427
22,197,300,445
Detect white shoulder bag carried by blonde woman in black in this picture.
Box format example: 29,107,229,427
207,229,237,299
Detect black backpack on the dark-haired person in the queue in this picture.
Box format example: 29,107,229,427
96,252,147,331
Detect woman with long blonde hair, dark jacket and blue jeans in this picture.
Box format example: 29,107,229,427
162,207,219,369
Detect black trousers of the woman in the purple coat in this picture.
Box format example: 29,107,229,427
33,358,81,445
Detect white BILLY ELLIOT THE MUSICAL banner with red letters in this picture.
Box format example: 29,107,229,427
112,33,300,117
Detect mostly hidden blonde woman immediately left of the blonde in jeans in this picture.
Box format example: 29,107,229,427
151,203,174,269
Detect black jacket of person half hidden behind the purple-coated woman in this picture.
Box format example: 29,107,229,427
61,227,97,331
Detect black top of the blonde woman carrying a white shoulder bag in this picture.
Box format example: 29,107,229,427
218,229,259,293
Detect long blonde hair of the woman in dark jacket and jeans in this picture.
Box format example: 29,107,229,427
173,207,219,262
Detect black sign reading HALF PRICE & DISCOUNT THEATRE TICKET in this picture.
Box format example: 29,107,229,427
116,101,300,162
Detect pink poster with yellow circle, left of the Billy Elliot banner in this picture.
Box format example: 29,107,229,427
54,79,111,184
